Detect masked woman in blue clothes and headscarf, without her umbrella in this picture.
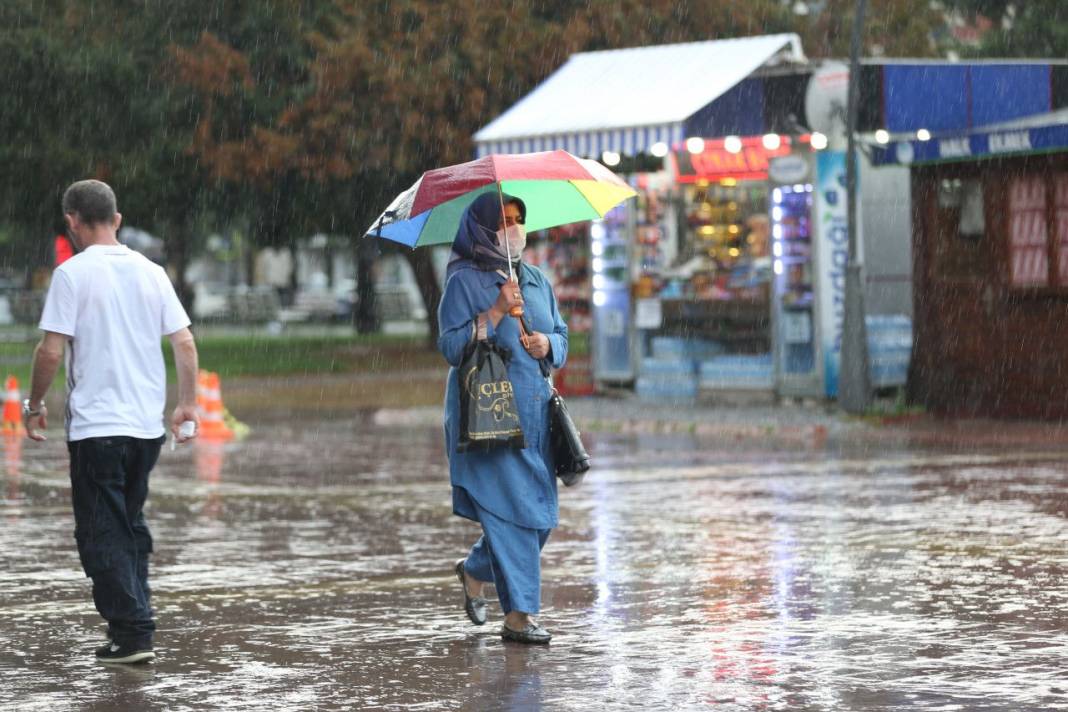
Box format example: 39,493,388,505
438,191,567,644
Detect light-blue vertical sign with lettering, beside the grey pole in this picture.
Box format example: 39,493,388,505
814,151,859,398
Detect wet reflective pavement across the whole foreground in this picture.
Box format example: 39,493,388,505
0,417,1068,712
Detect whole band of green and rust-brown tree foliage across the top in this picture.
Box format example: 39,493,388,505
0,0,1050,281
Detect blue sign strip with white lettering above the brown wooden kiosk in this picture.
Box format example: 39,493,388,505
871,123,1068,165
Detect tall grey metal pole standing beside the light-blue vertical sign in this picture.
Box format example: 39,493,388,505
838,0,871,414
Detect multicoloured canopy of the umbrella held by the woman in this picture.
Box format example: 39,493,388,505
366,151,635,248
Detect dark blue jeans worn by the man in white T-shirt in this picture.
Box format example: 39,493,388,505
67,437,164,649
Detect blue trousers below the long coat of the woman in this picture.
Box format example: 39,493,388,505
464,500,551,615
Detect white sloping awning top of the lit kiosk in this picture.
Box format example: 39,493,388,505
474,34,804,155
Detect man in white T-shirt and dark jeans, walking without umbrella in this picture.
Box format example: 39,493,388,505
22,180,200,663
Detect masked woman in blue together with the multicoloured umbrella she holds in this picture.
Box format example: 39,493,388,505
367,149,637,643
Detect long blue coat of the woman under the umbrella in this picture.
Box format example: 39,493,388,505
438,265,567,529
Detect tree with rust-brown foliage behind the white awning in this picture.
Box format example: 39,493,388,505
185,0,807,341
